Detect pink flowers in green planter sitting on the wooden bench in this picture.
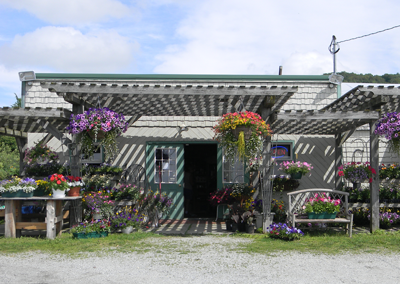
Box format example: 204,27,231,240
303,193,341,219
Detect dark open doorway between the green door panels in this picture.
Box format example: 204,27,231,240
184,144,217,218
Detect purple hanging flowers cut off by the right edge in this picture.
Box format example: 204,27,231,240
374,112,400,154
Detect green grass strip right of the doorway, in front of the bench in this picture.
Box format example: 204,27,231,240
236,230,400,254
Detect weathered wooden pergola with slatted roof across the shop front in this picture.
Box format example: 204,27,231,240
0,74,400,232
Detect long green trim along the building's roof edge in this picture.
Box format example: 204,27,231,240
36,73,329,81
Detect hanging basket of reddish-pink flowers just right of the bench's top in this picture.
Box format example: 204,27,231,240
338,162,376,184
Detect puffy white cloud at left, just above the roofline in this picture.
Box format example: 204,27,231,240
0,27,138,73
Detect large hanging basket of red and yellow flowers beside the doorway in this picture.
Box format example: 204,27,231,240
213,111,272,161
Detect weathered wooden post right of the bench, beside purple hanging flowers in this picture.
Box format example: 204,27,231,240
369,122,379,233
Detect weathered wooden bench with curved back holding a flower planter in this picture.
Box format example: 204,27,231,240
287,188,353,237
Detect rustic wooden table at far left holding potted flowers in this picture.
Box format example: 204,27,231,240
0,196,82,239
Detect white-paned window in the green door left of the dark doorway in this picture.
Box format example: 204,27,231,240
154,148,177,183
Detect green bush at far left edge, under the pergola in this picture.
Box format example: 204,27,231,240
0,140,19,180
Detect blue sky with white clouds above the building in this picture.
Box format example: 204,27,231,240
0,0,400,107
